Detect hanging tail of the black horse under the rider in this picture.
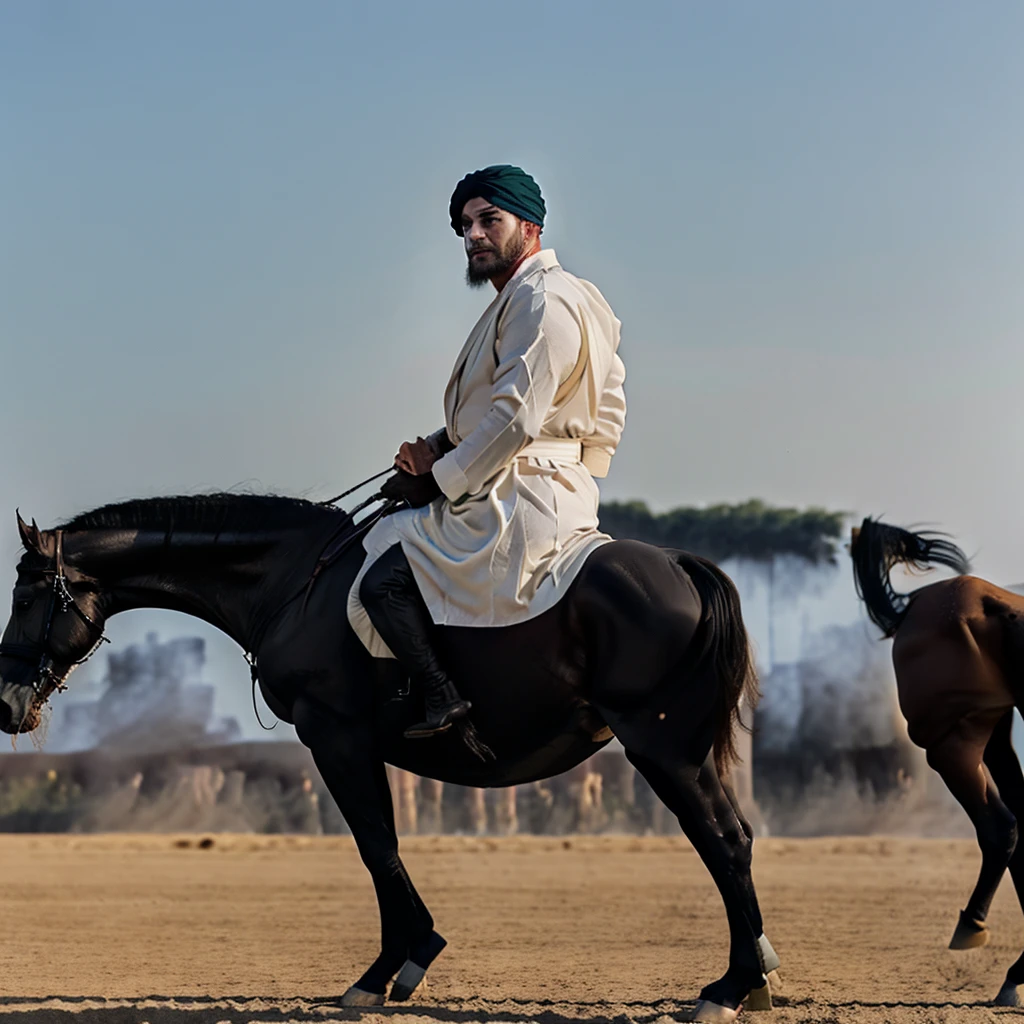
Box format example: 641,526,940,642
679,554,761,777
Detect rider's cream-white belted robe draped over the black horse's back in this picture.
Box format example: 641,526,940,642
348,249,626,657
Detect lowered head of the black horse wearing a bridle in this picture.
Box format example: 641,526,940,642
0,515,104,733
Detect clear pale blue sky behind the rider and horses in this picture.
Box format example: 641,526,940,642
0,0,1024,737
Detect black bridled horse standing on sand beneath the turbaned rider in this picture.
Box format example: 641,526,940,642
0,495,778,1021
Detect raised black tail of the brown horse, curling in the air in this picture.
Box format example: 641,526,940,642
850,518,971,637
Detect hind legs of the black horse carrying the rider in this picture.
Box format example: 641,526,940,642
606,713,778,1022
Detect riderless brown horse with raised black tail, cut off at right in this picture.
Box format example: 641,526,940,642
850,519,1024,1007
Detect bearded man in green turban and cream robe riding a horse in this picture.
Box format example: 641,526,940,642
348,165,626,738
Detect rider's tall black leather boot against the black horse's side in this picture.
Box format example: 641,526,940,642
359,544,471,739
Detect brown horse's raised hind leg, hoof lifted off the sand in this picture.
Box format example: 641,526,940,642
927,717,1017,949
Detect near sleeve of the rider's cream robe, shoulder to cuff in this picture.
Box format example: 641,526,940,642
433,286,582,503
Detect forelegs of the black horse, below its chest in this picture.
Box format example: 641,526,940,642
293,698,444,1006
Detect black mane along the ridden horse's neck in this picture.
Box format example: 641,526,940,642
59,494,346,534
